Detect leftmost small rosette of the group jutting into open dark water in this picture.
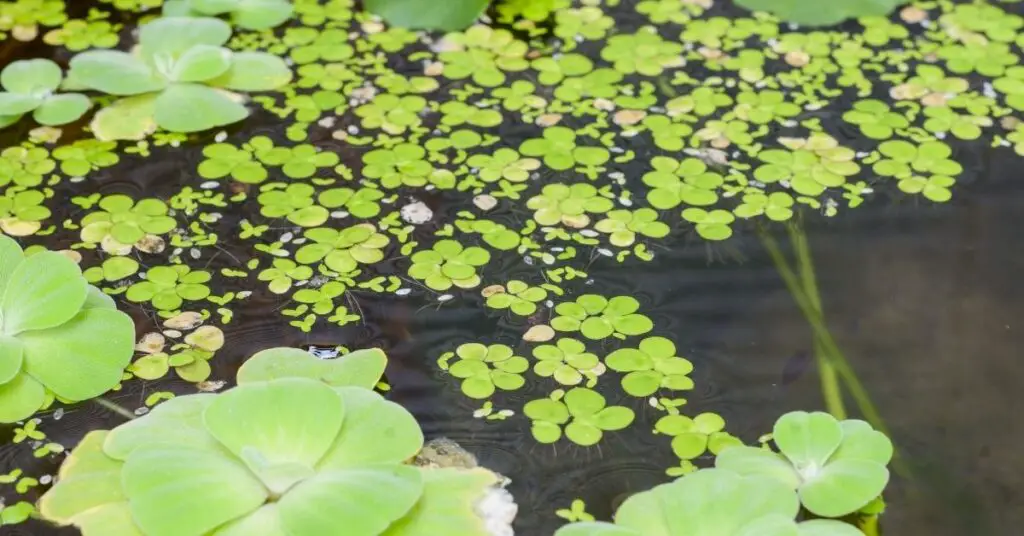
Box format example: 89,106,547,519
449,342,529,400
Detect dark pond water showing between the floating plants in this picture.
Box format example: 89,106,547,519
0,2,1024,536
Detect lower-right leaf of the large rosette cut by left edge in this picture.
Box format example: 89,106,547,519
18,305,135,401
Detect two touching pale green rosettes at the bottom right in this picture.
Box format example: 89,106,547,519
556,412,893,536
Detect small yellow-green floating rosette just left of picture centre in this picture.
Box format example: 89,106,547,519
409,239,490,291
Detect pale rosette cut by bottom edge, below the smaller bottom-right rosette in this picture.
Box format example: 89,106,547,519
555,468,861,536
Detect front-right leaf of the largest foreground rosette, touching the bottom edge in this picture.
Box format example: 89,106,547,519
278,465,423,534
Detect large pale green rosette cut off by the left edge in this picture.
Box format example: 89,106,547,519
0,236,135,422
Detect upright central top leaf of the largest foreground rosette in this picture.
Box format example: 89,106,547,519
203,378,346,479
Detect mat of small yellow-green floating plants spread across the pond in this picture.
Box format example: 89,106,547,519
0,0,1024,523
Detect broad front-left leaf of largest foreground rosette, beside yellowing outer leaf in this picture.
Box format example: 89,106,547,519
121,445,267,536
